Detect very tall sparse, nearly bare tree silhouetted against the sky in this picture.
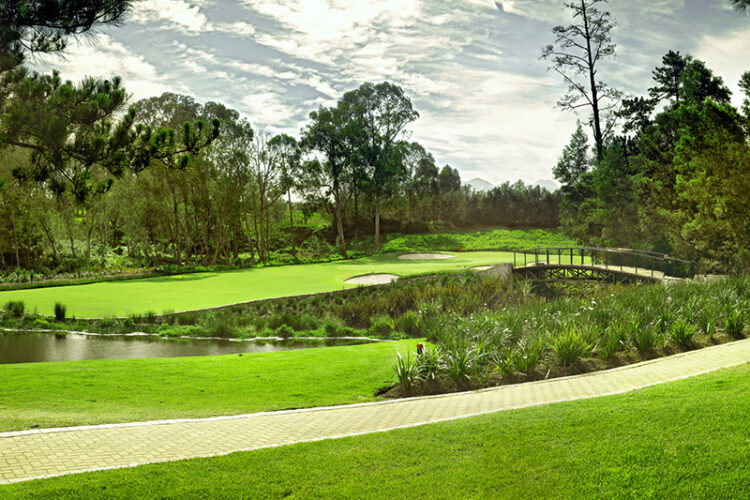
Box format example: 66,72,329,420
542,0,620,160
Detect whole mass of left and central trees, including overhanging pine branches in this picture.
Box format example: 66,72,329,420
0,0,558,272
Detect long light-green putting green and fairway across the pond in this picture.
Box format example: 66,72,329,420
0,252,513,318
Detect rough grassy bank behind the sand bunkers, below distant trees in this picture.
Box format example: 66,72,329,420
383,229,577,252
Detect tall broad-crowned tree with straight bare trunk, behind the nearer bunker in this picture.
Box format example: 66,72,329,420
342,82,419,251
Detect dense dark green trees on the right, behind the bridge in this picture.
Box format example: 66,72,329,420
555,51,750,271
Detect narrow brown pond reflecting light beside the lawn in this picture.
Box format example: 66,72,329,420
0,333,370,364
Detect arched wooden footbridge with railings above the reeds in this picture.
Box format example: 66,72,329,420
513,247,695,283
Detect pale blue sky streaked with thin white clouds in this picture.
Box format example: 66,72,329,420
31,0,750,184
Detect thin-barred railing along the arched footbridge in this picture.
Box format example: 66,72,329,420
513,247,695,278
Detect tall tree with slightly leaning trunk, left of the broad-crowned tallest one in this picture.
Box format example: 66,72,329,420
301,101,353,257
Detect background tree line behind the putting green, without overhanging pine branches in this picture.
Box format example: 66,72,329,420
0,83,559,271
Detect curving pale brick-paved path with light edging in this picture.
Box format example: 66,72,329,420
0,339,750,484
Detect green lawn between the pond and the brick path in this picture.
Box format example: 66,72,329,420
0,340,417,434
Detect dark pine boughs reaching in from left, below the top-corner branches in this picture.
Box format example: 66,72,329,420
0,73,219,202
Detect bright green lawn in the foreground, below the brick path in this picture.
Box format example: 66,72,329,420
5,366,750,499
